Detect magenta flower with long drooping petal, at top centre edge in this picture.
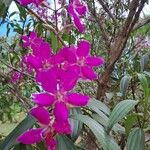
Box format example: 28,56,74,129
67,0,87,32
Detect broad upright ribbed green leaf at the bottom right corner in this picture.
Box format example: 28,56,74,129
127,128,145,150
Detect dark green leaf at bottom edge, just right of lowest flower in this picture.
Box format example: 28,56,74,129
57,135,77,150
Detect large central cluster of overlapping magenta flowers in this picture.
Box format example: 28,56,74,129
18,32,104,150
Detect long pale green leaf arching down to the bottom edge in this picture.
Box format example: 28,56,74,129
73,115,120,150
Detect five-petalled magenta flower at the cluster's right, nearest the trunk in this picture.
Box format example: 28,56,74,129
60,40,104,80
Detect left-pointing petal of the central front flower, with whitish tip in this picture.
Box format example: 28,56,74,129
32,93,54,107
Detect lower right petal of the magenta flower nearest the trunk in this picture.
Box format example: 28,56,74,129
81,67,97,80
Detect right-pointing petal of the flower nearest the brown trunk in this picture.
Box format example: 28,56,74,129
86,56,104,66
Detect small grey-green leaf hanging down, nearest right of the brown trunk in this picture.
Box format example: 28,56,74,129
120,75,131,97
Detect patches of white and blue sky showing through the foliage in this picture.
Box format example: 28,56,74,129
0,2,150,36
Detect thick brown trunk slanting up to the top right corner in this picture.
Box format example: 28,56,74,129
96,0,146,99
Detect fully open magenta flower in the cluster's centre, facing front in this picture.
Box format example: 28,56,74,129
32,68,89,129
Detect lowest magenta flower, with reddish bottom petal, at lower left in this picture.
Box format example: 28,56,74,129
17,107,56,150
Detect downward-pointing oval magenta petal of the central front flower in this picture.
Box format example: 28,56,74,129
54,102,69,122
